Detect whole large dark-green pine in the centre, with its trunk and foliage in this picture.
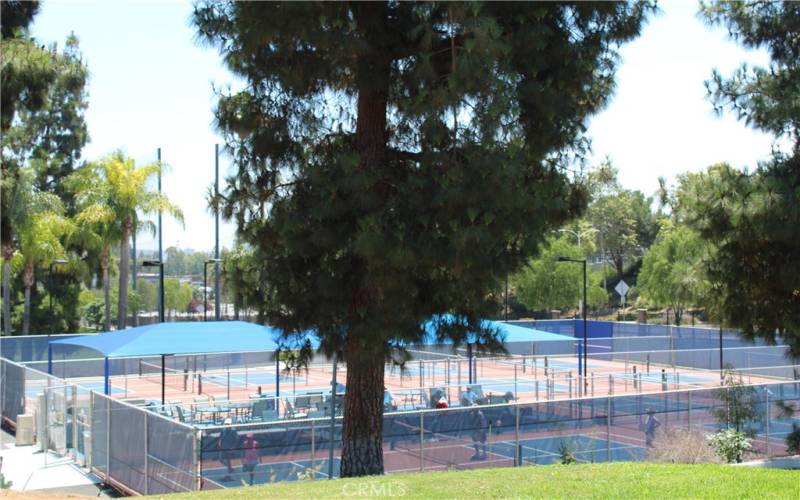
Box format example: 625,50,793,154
194,1,651,476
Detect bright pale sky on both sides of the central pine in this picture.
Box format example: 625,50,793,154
33,0,784,250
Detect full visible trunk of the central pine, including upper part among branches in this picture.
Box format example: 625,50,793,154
340,2,391,477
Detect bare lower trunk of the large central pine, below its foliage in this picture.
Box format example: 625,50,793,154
340,337,384,477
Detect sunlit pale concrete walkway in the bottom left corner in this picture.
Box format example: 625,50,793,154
0,431,113,497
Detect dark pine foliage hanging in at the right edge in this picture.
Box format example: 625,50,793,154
687,1,800,356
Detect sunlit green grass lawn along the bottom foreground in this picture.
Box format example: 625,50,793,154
169,463,800,500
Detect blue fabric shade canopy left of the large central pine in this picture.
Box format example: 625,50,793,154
50,321,317,358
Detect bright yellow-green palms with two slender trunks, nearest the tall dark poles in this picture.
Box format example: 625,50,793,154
73,152,183,330
